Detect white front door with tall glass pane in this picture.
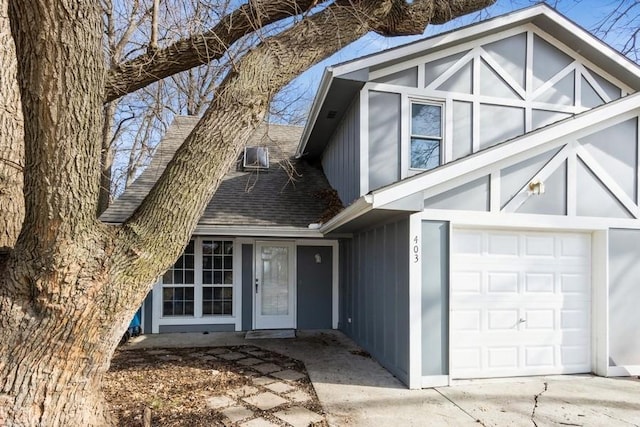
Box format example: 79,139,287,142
254,242,296,329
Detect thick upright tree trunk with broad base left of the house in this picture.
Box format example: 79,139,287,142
0,0,119,426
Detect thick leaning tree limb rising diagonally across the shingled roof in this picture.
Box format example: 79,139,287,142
116,0,493,290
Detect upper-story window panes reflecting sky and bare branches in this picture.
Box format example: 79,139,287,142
409,102,443,170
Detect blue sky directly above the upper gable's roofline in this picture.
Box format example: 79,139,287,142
293,0,637,104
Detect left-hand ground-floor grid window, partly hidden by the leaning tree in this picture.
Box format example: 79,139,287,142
162,240,195,316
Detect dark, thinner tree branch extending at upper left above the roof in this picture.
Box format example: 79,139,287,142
105,0,318,102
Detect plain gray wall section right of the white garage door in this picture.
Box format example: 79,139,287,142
609,230,640,366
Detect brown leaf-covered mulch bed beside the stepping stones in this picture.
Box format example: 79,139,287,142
103,346,328,427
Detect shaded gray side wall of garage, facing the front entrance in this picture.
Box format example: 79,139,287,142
340,218,409,383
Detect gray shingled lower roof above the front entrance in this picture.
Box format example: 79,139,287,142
100,116,338,228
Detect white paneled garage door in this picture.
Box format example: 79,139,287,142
450,229,591,378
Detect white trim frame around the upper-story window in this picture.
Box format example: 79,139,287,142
400,95,447,179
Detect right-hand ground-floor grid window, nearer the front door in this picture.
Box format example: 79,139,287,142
202,240,233,316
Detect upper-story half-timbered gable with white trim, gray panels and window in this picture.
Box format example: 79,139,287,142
299,6,640,211
